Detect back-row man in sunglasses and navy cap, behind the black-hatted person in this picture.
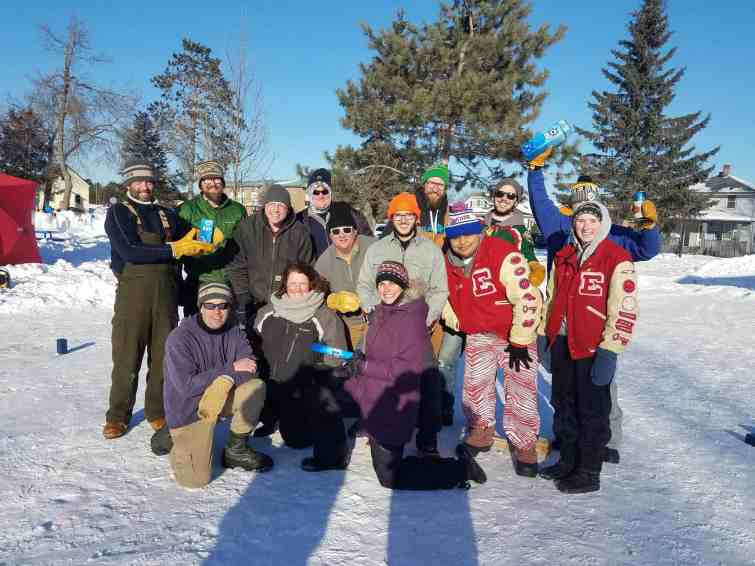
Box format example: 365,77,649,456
300,169,372,258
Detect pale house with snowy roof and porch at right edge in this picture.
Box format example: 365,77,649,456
664,165,755,257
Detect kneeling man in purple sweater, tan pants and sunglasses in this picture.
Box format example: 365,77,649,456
161,283,273,487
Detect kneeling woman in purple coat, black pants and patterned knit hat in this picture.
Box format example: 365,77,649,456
302,261,486,490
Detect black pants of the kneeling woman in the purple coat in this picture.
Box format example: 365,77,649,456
313,385,466,491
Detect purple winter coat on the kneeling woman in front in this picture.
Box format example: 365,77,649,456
344,292,433,445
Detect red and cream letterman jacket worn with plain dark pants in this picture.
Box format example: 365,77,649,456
539,239,639,360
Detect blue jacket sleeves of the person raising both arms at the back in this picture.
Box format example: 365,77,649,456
527,169,661,271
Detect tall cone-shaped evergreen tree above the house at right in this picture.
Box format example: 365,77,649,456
577,0,718,231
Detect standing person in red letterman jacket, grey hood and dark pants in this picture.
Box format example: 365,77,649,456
538,201,638,493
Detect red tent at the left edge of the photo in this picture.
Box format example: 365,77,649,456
0,173,41,265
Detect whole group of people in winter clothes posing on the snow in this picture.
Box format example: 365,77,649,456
103,146,660,493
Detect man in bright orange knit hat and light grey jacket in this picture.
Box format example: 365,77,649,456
357,193,448,456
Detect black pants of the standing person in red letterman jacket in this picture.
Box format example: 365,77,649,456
551,336,611,472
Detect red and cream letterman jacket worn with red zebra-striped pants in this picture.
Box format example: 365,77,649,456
443,236,543,346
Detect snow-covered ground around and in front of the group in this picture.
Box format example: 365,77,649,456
0,230,755,566
